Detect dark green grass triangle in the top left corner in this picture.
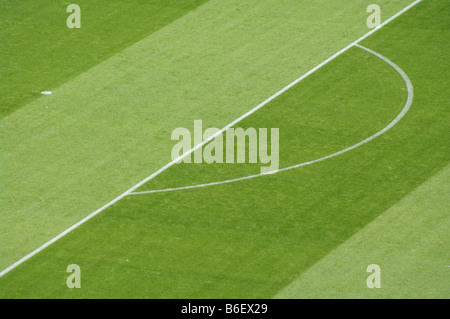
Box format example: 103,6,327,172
0,0,206,117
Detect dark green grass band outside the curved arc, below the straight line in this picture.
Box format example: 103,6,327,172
2,1,449,298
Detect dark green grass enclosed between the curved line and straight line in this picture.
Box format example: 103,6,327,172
137,48,407,191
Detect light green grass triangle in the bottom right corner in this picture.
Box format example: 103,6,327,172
275,165,450,298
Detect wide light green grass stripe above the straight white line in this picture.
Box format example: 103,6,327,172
0,0,410,269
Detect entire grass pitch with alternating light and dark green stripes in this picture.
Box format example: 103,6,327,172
0,0,450,298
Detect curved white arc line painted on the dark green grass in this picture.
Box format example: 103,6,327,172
130,44,414,195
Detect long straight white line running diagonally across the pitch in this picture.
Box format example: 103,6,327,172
0,0,422,277
